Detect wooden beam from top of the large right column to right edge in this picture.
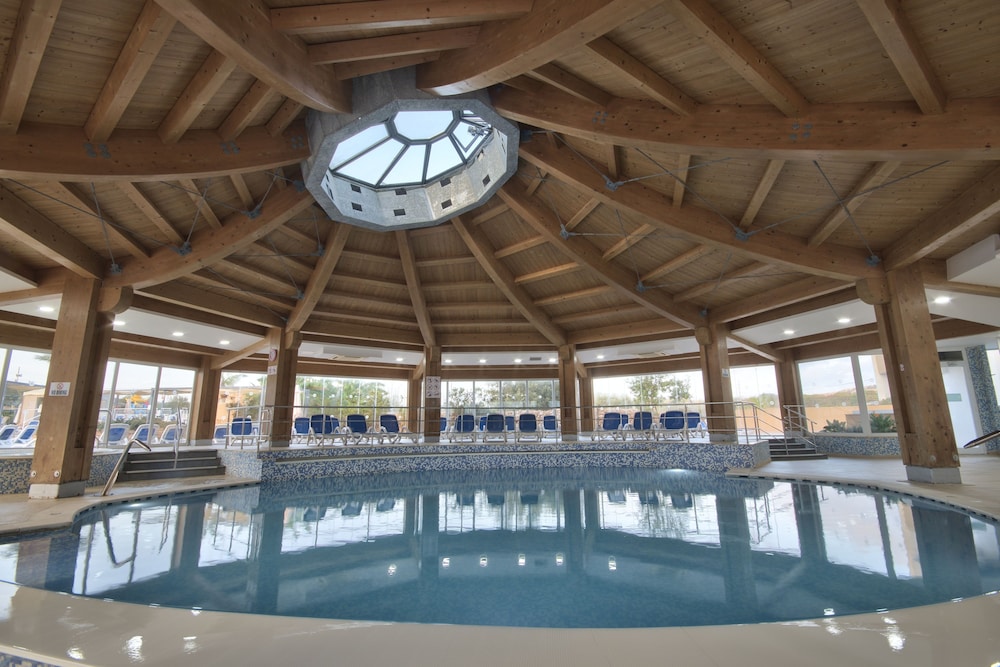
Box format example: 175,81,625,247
882,167,1000,270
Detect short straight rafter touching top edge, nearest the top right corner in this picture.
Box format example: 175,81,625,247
857,0,948,114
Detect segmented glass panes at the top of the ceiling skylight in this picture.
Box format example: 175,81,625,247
330,110,493,188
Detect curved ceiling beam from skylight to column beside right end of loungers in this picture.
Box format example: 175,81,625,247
497,181,703,328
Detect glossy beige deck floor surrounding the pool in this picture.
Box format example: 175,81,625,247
0,455,1000,667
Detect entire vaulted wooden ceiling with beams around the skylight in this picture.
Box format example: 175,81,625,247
0,0,1000,364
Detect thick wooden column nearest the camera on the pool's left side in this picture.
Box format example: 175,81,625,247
28,278,132,498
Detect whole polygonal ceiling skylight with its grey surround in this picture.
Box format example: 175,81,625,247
303,69,518,230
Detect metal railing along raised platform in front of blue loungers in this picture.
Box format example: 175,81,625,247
221,402,804,450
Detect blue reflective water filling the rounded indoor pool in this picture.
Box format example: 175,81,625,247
0,468,1000,628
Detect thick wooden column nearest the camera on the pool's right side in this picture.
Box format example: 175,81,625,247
857,264,962,484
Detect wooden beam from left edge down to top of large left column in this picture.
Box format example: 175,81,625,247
0,185,108,278
